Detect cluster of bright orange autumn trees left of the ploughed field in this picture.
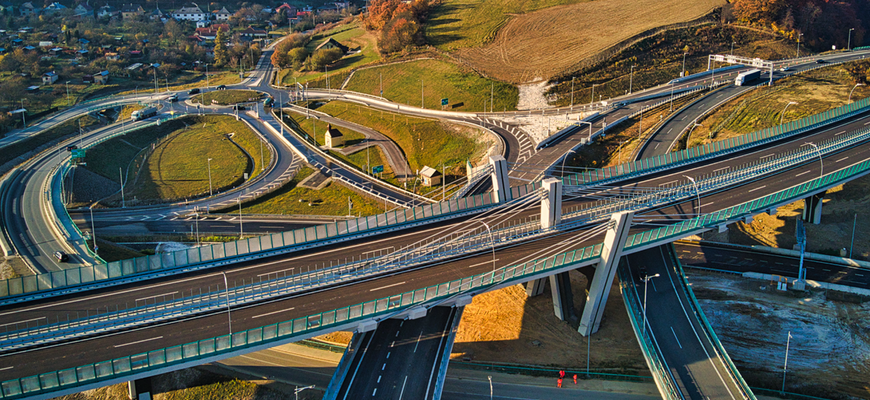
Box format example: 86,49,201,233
360,0,433,54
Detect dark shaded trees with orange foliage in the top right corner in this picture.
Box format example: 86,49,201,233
732,0,870,51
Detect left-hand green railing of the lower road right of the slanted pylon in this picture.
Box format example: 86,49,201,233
617,267,682,400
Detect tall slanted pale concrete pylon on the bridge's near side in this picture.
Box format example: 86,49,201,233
577,212,634,336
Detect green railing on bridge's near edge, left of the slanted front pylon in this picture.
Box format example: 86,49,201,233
0,244,602,399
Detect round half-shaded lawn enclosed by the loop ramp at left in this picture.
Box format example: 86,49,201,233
86,115,271,204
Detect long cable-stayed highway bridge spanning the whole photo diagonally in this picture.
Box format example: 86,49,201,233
0,90,870,398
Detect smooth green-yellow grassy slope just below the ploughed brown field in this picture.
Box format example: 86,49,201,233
346,60,519,111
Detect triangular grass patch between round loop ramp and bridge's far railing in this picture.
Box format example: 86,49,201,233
235,167,384,215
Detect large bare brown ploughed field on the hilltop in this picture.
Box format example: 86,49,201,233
456,0,725,83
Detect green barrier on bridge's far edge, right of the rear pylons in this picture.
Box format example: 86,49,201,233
563,94,870,186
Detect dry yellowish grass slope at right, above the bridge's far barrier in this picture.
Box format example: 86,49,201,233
687,66,870,147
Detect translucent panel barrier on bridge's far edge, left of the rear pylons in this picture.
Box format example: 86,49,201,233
0,183,504,303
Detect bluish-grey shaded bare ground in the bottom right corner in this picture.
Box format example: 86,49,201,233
687,269,870,399
